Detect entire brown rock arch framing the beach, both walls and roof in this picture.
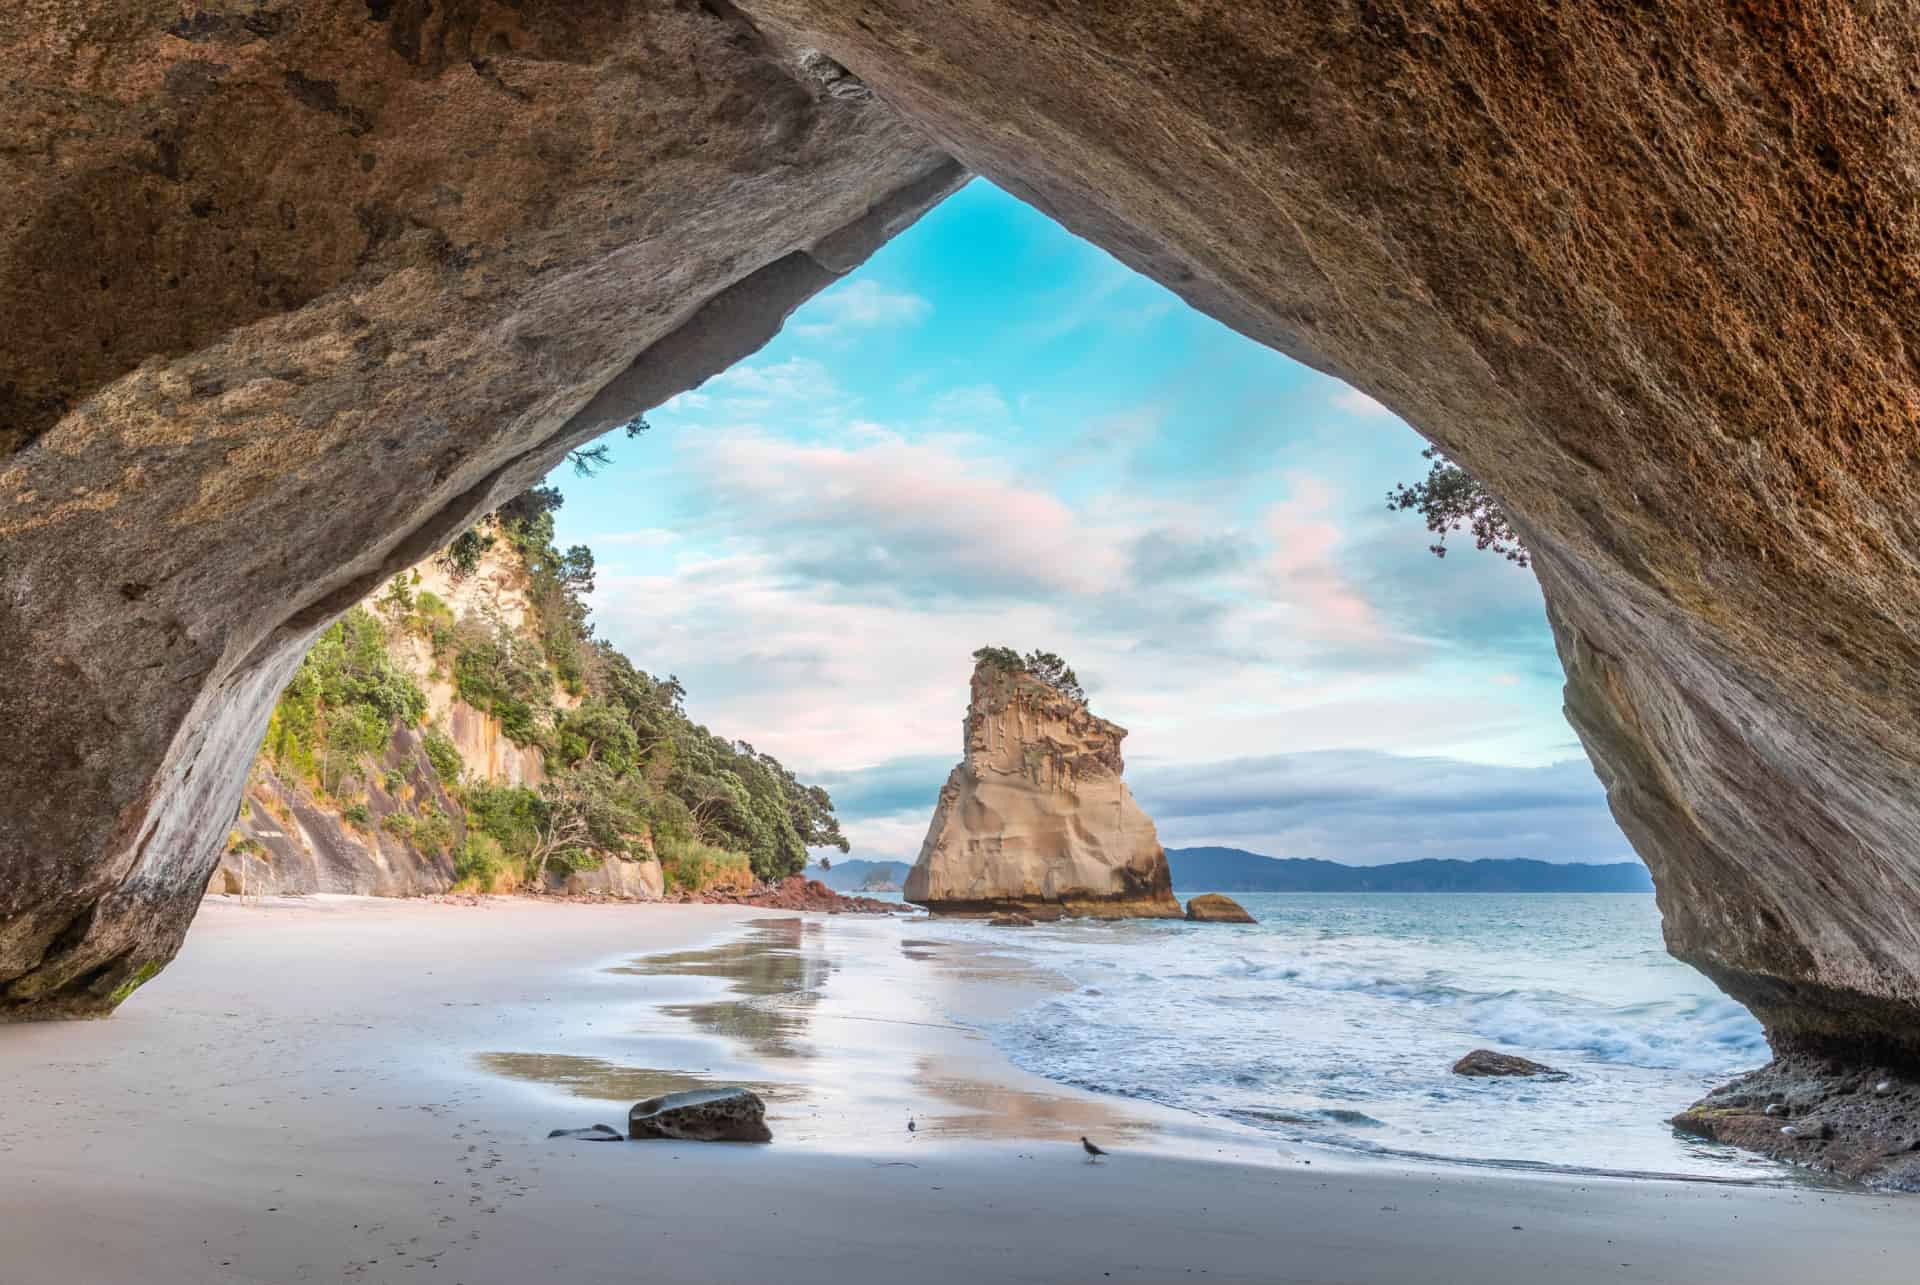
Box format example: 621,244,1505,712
0,0,1920,1083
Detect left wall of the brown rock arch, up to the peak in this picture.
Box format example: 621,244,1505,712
0,0,962,1018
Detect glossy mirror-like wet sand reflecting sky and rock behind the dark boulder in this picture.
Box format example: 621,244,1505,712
476,918,1160,1152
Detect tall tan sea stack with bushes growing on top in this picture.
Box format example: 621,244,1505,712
906,647,1181,918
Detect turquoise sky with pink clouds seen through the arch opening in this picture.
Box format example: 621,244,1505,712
553,181,1630,862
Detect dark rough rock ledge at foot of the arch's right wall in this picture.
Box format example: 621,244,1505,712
1672,1056,1920,1191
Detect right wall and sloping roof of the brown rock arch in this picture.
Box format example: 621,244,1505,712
743,0,1920,1064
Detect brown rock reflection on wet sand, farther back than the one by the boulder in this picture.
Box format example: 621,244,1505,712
611,918,833,1058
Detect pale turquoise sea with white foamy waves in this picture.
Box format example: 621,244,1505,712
916,893,1766,1176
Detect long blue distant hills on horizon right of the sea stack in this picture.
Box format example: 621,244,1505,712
1167,847,1653,893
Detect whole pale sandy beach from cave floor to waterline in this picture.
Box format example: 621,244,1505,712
0,899,1920,1285
